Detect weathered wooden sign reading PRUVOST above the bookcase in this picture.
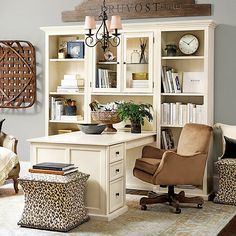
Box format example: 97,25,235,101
62,0,211,22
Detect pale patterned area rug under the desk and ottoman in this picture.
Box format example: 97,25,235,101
0,185,236,236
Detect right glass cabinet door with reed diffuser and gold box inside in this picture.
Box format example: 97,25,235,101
123,32,153,92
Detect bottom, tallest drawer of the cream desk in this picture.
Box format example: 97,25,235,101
110,177,124,213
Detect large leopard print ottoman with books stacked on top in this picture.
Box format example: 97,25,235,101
18,172,89,232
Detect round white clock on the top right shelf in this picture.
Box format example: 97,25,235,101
179,34,199,55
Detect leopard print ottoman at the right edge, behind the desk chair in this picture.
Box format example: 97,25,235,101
214,159,236,205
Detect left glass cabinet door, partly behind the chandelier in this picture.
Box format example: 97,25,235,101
91,39,121,93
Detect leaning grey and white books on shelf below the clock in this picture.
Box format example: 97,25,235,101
161,66,181,93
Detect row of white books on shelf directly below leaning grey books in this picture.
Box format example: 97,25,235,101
161,102,205,125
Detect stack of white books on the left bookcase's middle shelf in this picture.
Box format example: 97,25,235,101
57,75,84,93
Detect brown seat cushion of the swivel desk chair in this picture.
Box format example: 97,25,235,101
135,158,161,175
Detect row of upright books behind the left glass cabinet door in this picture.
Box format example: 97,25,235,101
96,68,117,88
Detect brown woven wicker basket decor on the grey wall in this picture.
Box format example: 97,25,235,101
0,40,36,109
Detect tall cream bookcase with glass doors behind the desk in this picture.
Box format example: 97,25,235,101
41,20,215,196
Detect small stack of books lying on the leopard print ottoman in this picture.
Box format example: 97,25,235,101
29,162,78,175
